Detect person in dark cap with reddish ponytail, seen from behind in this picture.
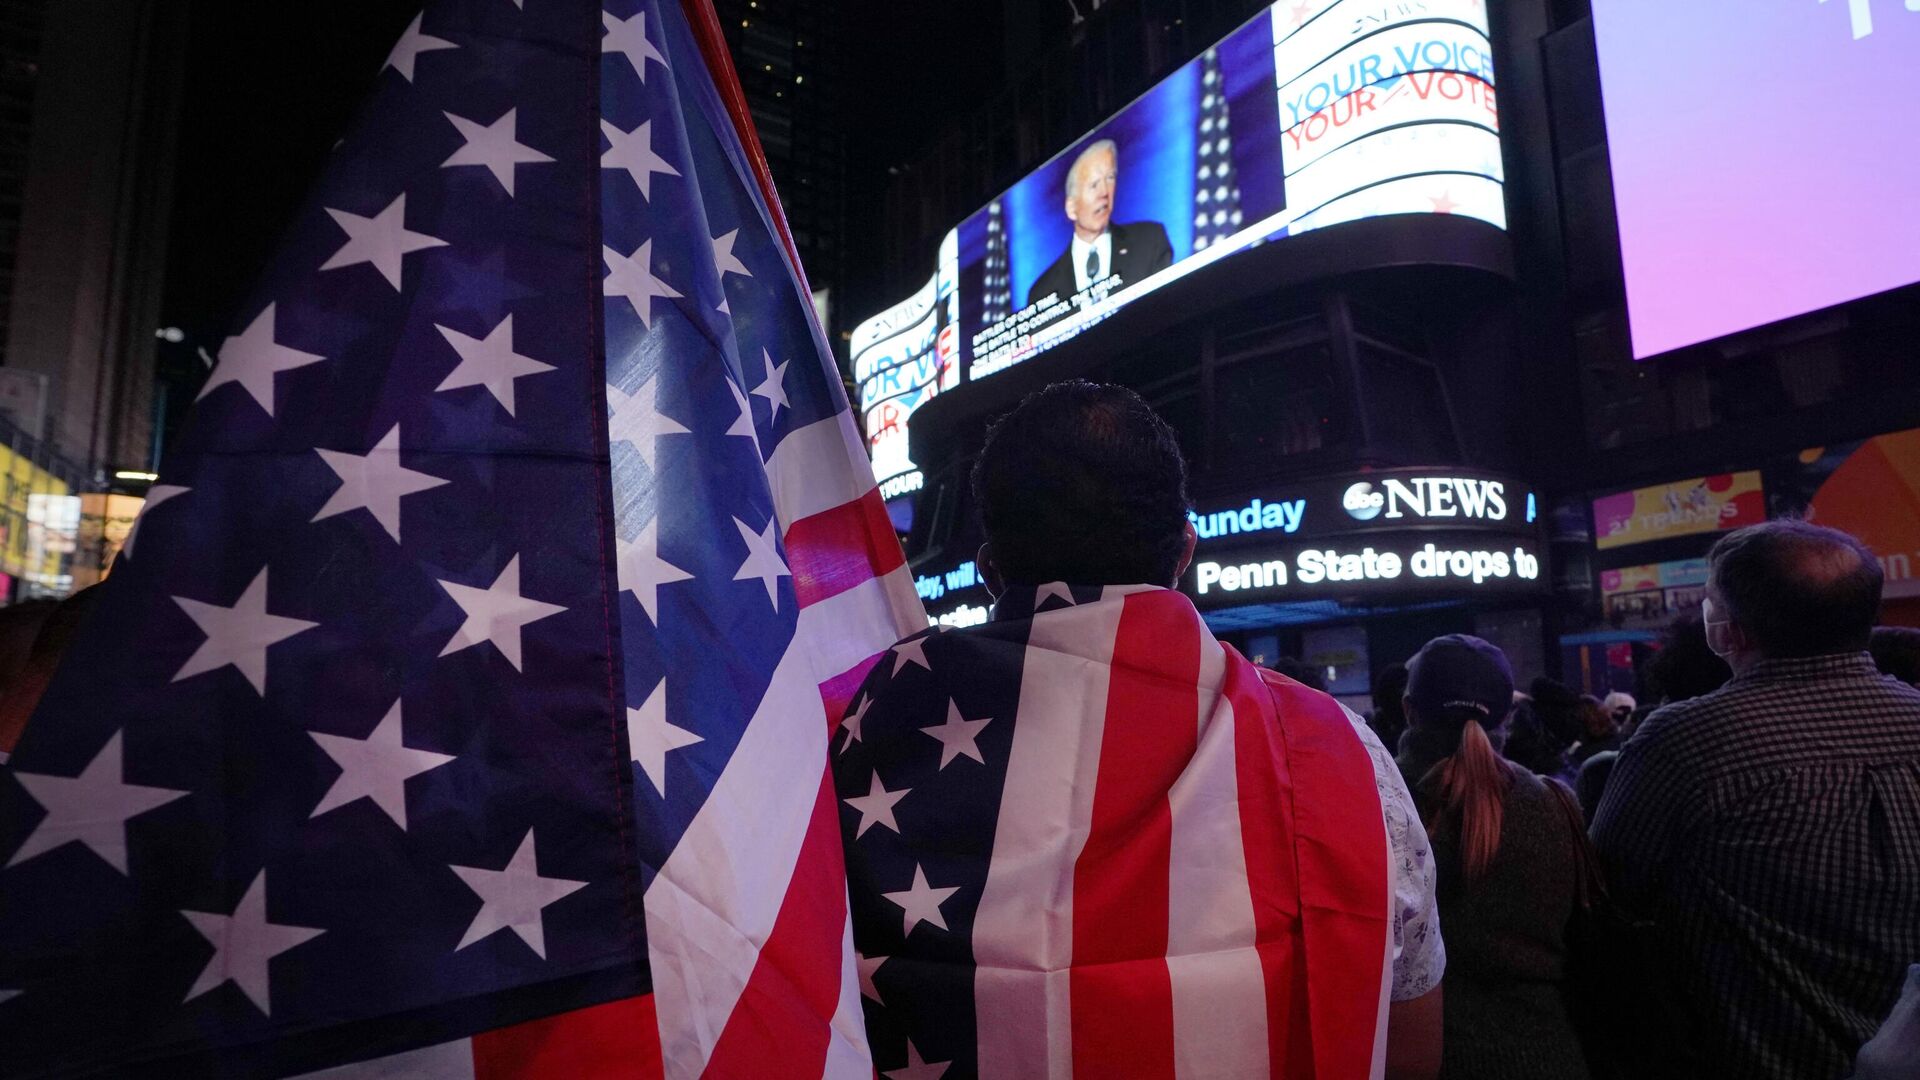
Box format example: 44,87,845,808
1398,634,1590,1080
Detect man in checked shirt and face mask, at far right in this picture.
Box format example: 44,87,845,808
1592,521,1920,1078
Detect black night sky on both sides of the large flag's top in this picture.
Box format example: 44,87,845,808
163,0,1002,350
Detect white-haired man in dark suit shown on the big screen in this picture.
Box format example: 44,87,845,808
1027,138,1173,307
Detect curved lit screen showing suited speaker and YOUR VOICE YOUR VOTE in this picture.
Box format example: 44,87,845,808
851,0,1505,484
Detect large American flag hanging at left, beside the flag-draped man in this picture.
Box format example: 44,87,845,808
0,0,925,1076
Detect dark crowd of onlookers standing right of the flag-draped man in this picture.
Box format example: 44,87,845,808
1369,521,1920,1080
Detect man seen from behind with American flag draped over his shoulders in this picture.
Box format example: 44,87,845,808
833,382,1446,1080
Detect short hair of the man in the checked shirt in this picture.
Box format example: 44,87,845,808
1707,519,1882,659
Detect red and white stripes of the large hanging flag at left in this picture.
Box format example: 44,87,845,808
645,411,925,1078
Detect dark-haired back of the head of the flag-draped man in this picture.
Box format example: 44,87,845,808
973,379,1187,584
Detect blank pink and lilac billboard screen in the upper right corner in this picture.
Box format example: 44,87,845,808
1594,0,1920,357
